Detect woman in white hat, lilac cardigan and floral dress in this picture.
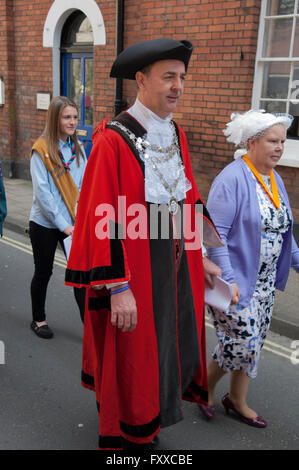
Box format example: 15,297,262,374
201,110,299,427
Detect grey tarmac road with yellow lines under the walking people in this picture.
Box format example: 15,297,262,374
0,230,299,450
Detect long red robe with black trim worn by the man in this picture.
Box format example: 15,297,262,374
66,113,224,449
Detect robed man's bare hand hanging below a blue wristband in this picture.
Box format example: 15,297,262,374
111,289,137,332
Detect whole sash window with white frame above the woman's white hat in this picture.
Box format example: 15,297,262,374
253,0,299,167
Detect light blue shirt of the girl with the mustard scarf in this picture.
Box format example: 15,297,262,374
30,140,86,232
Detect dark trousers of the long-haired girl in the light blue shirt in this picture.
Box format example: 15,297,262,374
29,221,86,323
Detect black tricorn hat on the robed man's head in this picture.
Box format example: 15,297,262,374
110,38,193,80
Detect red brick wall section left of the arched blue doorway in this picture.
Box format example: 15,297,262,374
0,0,52,177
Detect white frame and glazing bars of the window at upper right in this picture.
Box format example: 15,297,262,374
252,0,299,168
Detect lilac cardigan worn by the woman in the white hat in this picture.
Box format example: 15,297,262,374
207,157,299,307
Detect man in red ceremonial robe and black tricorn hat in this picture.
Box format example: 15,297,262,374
66,39,222,449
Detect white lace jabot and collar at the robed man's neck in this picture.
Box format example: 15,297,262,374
127,98,191,204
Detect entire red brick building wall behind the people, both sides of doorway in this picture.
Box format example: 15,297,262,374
0,0,299,222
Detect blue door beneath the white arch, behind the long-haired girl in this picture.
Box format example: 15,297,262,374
62,53,93,157
